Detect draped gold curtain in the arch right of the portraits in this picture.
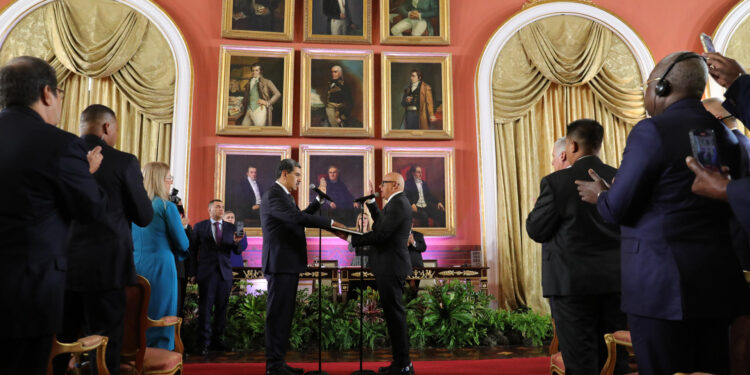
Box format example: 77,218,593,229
494,16,645,312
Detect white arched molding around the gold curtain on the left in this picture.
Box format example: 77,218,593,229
0,0,193,205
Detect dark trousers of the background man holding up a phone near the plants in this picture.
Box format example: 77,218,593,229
198,271,232,346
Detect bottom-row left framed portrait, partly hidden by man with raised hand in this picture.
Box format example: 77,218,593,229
214,144,292,236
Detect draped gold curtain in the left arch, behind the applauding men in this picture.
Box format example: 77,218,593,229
0,0,175,163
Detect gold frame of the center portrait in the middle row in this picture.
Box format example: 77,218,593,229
300,49,375,138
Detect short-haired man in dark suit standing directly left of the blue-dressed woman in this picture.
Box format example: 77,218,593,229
55,104,154,374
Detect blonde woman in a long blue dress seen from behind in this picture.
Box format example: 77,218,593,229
132,162,189,350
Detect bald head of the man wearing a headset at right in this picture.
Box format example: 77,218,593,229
651,51,708,98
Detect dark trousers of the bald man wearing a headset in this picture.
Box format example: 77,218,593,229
632,314,729,375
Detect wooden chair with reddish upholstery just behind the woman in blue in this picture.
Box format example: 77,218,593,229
120,275,184,375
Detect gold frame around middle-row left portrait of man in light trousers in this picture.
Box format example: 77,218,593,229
216,45,294,136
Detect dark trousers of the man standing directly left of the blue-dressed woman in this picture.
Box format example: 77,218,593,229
53,289,126,375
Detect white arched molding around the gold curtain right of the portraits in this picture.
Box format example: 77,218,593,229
475,0,654,291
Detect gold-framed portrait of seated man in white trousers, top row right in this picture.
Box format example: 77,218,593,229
380,0,446,45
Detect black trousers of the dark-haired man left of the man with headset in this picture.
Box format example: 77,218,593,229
550,293,628,375
